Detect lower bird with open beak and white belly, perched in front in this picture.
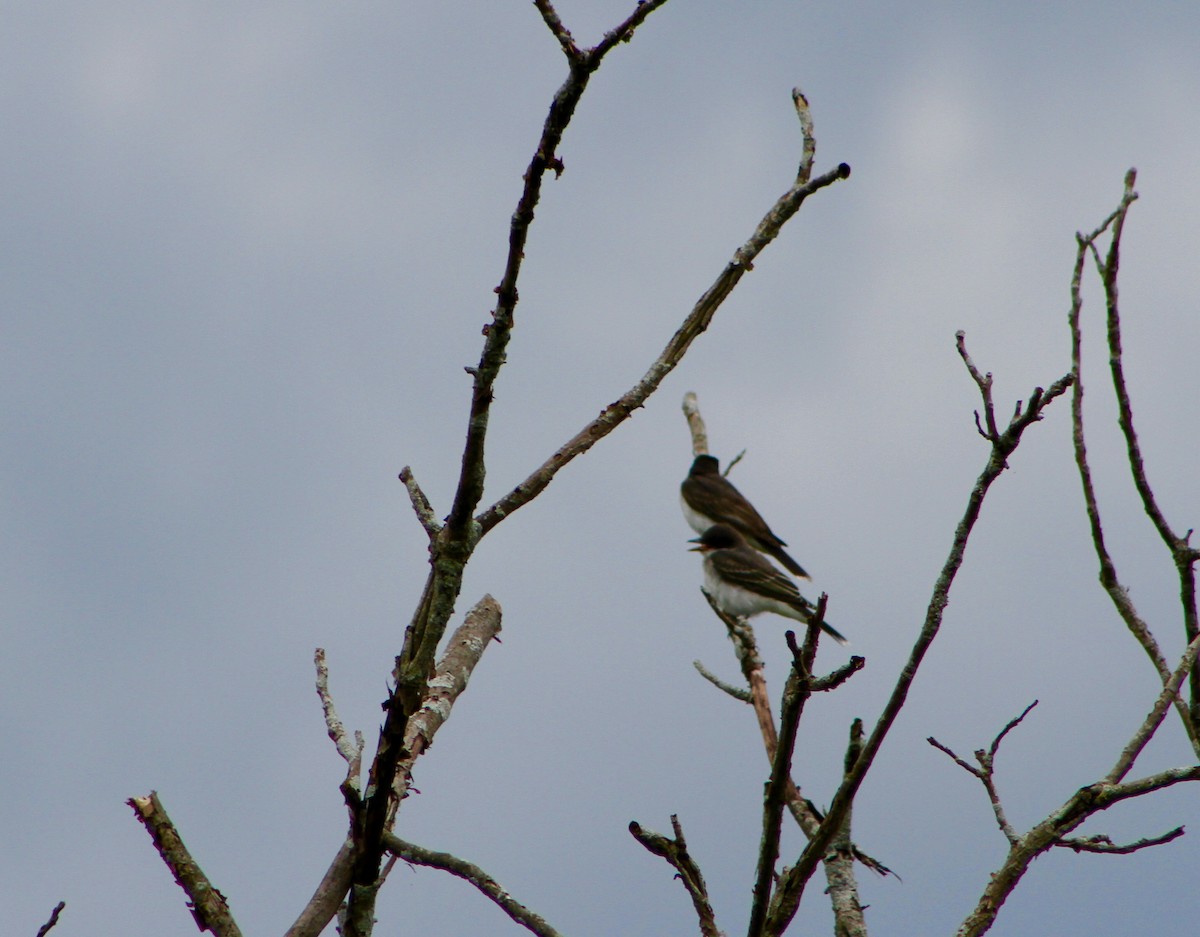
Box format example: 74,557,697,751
688,524,850,644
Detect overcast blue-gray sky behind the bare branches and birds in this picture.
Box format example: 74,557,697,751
0,0,1200,937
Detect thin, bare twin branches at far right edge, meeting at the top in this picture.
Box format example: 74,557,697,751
1068,169,1200,739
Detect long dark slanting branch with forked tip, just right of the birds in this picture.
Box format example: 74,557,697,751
763,332,1072,935
